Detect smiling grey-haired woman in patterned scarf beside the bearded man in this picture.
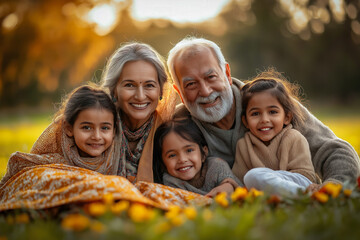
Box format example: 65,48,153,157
102,43,176,182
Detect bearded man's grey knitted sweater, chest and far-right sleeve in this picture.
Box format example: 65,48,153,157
175,78,360,183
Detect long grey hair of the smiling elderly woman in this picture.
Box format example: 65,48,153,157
102,42,168,97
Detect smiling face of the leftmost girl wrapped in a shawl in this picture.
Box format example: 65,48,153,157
66,108,115,157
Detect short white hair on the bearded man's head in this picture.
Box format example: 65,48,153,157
167,37,226,86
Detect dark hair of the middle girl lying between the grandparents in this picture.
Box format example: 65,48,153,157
153,118,207,183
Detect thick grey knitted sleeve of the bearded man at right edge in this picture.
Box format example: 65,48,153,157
298,106,360,183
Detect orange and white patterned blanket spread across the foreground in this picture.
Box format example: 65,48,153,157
0,164,212,211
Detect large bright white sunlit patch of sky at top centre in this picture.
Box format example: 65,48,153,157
132,0,229,22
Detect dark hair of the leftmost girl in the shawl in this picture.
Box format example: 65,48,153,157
56,84,118,133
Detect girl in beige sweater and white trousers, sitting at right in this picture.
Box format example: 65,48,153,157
232,70,319,196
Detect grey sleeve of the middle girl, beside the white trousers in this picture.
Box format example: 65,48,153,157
207,157,243,189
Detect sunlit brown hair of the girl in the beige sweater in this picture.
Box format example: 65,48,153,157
241,68,305,127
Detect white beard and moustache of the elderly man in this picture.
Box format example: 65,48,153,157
184,83,234,123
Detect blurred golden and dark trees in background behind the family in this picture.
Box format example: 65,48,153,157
0,0,360,108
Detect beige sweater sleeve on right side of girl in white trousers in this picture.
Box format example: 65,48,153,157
283,129,316,183
